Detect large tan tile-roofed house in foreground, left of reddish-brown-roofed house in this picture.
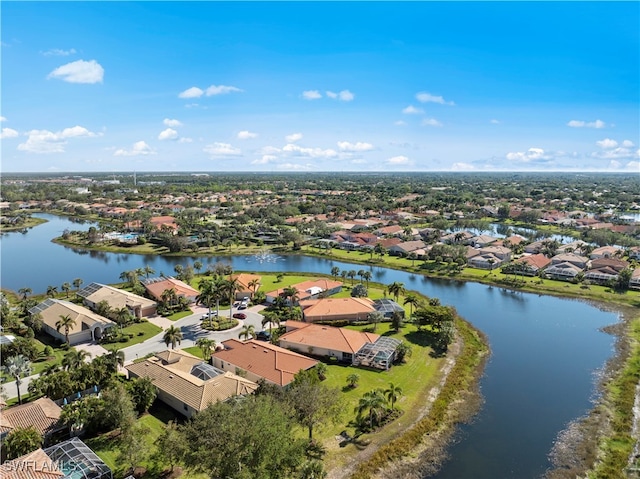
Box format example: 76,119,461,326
125,350,258,418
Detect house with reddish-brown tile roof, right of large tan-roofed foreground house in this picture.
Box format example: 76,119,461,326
211,339,318,387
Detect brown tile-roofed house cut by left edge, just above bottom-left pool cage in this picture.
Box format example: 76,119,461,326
0,397,66,444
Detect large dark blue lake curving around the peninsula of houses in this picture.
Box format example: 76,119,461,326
0,215,620,479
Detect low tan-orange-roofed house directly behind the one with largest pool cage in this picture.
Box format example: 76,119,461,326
300,297,376,323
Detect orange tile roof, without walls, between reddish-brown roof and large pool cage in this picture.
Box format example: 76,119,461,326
279,321,380,354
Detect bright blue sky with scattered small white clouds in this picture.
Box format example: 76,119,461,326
0,1,640,174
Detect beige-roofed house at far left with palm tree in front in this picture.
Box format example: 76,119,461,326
29,298,116,345
